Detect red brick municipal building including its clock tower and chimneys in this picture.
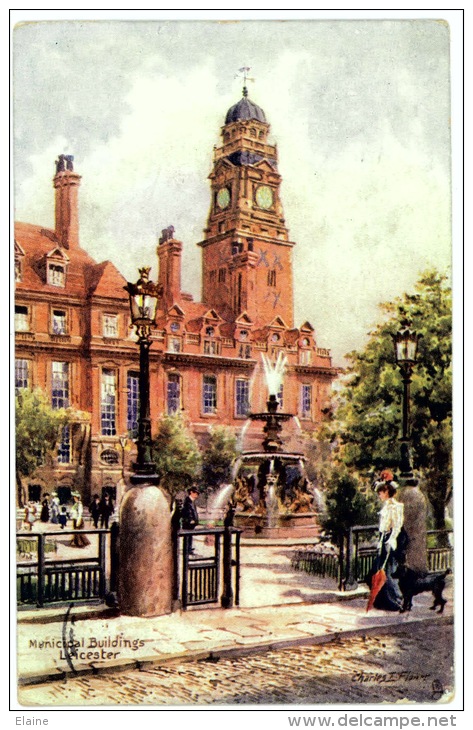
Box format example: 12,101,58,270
15,90,337,506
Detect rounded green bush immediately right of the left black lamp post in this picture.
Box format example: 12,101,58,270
152,413,202,497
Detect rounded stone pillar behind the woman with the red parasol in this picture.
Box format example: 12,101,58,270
396,483,429,573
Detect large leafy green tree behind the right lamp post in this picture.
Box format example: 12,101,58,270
330,271,452,529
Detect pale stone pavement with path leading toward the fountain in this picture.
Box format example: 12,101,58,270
17,538,453,685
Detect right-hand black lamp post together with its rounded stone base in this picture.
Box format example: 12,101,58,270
393,318,429,575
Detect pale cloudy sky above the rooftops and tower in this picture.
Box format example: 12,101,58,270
13,13,451,364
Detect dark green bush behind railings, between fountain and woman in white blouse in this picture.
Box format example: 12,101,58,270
321,468,377,538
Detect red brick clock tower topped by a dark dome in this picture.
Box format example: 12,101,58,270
199,87,294,328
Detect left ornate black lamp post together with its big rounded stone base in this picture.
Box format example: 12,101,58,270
118,267,173,616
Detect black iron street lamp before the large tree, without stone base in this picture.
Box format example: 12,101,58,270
393,318,422,483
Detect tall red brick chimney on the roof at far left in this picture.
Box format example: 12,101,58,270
53,155,81,248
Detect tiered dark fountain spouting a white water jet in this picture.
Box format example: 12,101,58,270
227,353,320,538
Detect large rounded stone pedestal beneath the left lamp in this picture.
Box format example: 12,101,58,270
118,485,173,616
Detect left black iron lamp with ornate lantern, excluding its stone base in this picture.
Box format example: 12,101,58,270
124,266,162,484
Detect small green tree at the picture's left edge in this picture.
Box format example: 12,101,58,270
15,388,74,507
